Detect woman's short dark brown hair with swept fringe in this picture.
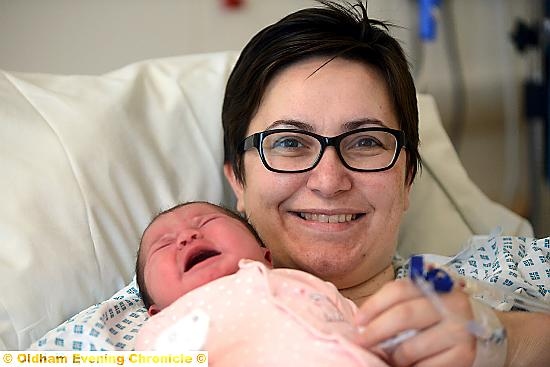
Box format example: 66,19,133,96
222,0,421,183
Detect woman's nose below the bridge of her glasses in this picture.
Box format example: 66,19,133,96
306,147,352,197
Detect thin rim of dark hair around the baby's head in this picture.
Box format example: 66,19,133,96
136,201,265,309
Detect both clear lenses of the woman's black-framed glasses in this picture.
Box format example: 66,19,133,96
262,131,397,171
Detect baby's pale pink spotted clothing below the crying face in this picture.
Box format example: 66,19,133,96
136,260,387,367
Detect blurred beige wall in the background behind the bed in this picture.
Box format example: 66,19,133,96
0,0,550,235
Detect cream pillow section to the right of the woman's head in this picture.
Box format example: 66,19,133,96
398,95,533,257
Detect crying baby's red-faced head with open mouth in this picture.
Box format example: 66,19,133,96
136,202,271,315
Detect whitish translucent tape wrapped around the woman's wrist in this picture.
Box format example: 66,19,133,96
470,297,508,367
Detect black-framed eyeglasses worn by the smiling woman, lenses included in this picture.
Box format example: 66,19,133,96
238,127,405,173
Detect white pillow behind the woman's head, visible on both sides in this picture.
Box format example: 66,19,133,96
0,52,532,350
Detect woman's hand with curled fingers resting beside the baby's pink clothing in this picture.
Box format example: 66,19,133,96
356,279,476,367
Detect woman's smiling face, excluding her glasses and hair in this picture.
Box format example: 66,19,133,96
225,58,410,289
